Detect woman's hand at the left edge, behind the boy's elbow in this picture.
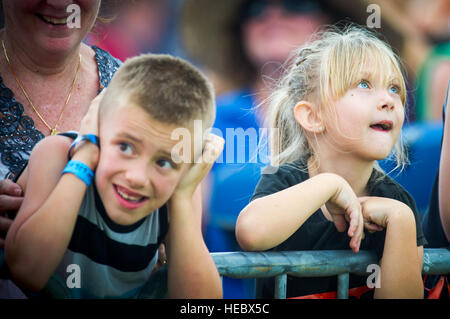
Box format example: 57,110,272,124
0,179,23,249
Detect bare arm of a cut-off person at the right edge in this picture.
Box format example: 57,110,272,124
439,99,450,242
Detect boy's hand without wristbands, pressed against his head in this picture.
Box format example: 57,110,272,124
172,134,225,200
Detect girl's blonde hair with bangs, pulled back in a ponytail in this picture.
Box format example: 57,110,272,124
267,25,406,174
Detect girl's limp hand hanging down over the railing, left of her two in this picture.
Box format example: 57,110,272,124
325,178,364,253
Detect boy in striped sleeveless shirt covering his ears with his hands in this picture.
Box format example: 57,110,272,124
6,55,223,298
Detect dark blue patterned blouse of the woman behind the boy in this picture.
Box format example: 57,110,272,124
0,46,121,179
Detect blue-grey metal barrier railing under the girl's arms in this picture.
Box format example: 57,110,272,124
211,248,450,299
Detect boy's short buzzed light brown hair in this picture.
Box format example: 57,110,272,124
100,54,215,129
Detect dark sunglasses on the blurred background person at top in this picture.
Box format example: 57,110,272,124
243,0,320,18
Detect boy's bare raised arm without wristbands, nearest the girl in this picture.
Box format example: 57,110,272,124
166,137,223,298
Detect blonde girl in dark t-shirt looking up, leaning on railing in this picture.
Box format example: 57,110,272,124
236,26,426,298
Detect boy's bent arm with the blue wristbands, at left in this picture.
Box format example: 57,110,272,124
5,136,98,290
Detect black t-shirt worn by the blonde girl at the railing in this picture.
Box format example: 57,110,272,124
251,161,427,298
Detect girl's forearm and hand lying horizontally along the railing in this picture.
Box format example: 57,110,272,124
236,173,363,252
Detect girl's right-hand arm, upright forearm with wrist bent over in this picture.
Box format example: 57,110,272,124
361,197,423,299
